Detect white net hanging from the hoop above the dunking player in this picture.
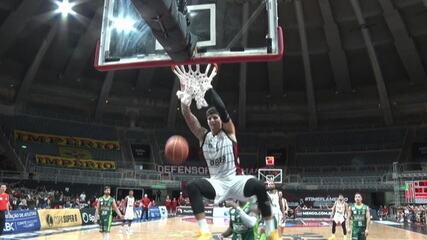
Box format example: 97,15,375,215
172,64,218,109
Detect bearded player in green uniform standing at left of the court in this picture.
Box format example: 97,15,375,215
95,186,123,238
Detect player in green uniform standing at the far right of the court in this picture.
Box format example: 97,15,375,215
348,193,371,240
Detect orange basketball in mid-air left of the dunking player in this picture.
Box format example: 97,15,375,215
165,135,189,164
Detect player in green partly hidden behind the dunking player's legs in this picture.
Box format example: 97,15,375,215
221,201,267,240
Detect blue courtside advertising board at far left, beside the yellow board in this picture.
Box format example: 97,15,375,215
3,210,40,234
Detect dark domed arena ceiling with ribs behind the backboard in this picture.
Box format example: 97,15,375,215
0,0,427,129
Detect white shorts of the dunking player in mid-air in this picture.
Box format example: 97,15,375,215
205,175,255,204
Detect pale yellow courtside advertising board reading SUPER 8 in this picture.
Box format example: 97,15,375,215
37,209,82,230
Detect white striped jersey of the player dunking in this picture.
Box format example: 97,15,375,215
202,130,237,179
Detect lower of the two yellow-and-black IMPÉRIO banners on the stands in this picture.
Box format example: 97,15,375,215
36,154,116,170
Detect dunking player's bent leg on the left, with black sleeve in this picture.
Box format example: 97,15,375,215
187,179,216,235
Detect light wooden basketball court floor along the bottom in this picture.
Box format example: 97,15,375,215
0,217,427,240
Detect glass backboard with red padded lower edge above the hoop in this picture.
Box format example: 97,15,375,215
95,0,284,71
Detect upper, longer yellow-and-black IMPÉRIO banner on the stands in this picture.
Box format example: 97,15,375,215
15,130,120,151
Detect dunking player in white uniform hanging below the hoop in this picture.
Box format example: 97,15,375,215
174,66,280,240
